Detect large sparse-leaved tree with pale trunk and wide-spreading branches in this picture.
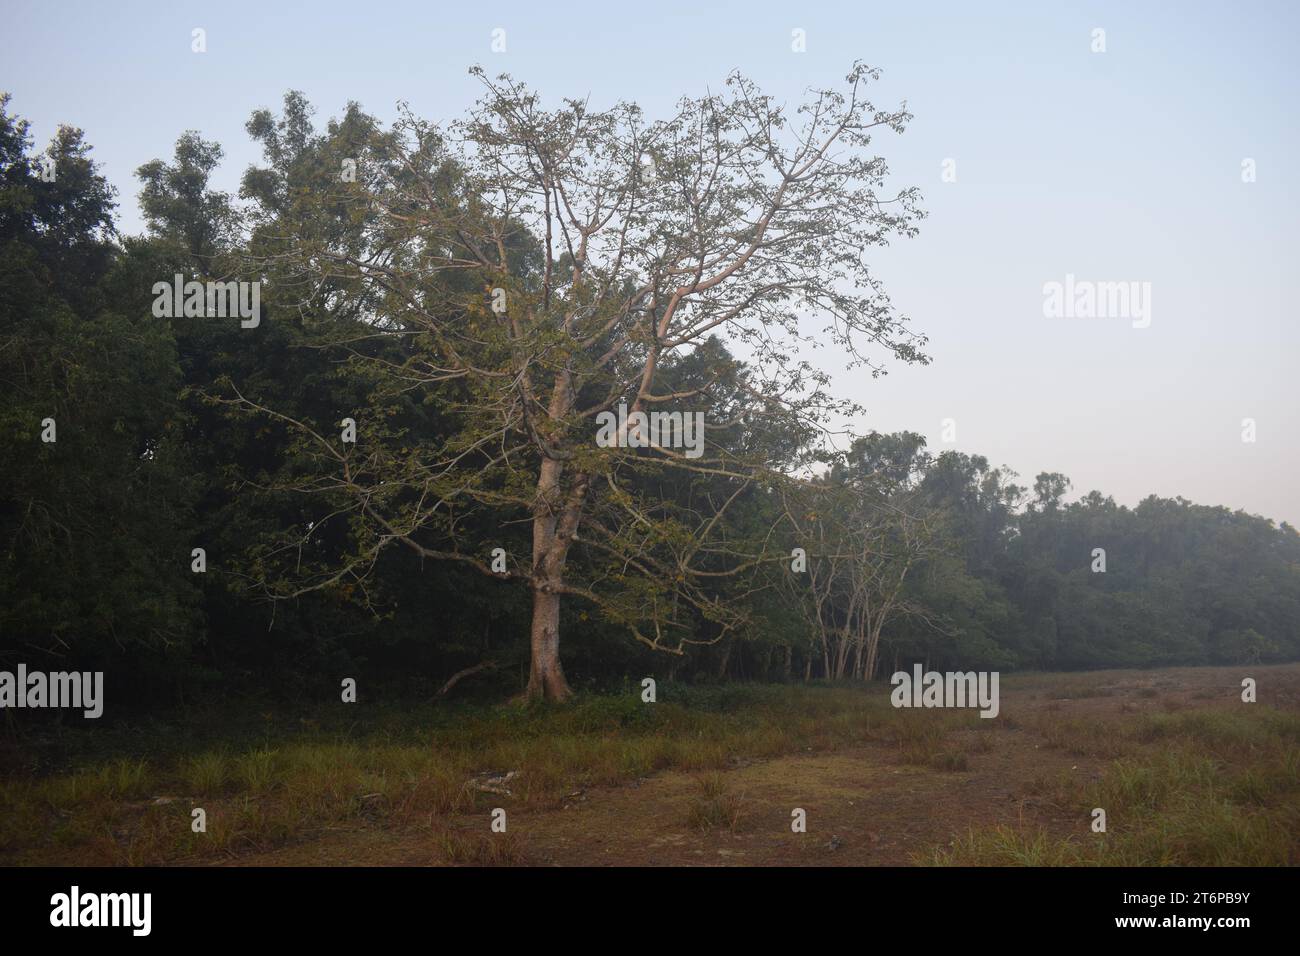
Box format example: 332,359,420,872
233,65,924,698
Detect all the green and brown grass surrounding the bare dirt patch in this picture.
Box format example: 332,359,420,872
0,674,1300,865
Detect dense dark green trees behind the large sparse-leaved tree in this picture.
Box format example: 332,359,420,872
0,89,1300,706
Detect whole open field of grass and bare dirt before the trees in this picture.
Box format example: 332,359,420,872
0,665,1300,866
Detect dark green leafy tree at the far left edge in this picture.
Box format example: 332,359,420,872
0,98,202,680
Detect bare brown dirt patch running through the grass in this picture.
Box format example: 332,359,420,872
222,665,1300,866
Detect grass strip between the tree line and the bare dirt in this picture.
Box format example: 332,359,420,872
0,685,915,865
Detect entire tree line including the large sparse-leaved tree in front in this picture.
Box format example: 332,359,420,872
0,78,1300,713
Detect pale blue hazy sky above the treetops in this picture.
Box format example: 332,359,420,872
0,0,1300,523
